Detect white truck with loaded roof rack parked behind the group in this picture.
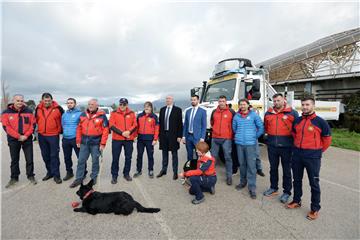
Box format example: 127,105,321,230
190,58,340,142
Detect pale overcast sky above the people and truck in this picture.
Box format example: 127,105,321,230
1,1,359,104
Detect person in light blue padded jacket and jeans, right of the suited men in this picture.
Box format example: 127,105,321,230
232,99,264,199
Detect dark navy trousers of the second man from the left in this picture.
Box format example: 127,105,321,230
38,134,60,177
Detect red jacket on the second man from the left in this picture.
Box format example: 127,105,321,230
35,101,64,136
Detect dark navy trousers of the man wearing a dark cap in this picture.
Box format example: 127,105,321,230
111,140,134,178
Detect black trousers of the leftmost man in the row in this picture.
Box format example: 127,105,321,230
8,137,35,180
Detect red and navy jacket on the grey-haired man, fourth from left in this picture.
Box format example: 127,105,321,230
76,110,109,146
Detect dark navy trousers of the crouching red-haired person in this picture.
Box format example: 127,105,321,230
189,176,216,200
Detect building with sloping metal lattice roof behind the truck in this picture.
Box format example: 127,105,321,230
257,28,360,101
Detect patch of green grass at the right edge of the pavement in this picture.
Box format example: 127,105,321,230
331,128,360,151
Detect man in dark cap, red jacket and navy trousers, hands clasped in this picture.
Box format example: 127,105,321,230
109,98,137,184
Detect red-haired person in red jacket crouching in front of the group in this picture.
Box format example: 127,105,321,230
180,142,217,204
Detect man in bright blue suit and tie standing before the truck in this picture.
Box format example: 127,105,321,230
182,95,206,161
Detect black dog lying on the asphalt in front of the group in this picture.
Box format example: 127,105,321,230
73,180,160,215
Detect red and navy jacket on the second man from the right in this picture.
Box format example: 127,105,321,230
264,106,299,147
